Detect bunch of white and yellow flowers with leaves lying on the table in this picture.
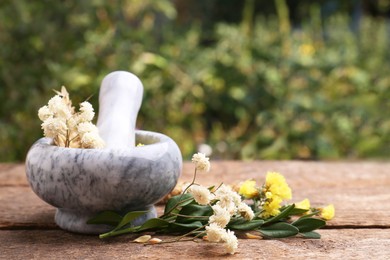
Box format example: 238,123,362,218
87,153,334,254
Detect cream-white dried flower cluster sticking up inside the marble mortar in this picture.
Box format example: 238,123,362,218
38,87,104,148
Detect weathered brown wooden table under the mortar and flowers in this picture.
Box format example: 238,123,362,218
0,161,390,259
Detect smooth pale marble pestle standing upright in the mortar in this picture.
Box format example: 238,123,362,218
97,71,143,149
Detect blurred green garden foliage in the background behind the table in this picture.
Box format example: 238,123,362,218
0,0,390,161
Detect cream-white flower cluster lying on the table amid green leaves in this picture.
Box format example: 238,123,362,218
188,184,254,254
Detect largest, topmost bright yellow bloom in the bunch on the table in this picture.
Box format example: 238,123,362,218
265,172,291,199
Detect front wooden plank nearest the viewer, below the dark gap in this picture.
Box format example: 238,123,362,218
0,229,390,259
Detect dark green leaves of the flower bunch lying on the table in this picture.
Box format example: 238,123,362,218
87,193,326,238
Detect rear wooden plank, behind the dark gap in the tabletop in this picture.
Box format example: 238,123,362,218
0,161,390,227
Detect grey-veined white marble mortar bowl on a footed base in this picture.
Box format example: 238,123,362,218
26,130,182,234
